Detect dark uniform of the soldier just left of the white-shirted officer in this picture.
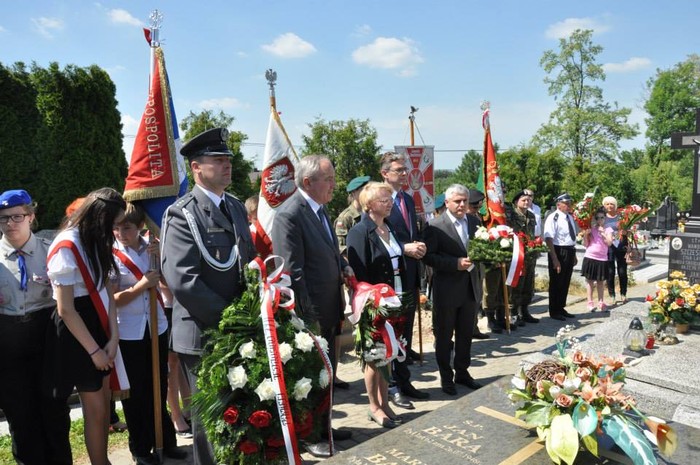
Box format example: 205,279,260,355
508,191,539,325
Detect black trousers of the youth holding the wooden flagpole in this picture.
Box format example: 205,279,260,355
119,326,177,456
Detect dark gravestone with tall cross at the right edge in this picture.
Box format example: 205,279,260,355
668,108,700,283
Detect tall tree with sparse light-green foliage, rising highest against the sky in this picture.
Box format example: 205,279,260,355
535,29,638,170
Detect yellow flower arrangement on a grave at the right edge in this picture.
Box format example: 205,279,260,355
646,271,700,324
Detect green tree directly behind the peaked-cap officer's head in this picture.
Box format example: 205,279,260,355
180,110,256,202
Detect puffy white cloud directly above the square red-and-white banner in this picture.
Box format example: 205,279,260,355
352,37,423,77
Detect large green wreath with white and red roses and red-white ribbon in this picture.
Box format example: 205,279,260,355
193,256,331,465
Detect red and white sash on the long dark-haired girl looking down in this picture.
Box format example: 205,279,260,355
46,229,129,397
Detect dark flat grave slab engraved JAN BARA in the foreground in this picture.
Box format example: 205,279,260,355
323,377,700,465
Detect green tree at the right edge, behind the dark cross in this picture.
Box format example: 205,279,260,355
644,54,700,163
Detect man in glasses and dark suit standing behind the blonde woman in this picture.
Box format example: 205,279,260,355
380,152,429,409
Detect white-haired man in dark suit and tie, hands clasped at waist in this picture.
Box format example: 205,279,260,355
425,184,482,395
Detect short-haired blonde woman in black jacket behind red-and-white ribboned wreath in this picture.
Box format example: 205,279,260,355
347,182,405,428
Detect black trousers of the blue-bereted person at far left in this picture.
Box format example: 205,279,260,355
0,308,73,465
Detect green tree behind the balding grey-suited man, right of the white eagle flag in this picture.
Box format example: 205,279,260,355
301,117,381,218
